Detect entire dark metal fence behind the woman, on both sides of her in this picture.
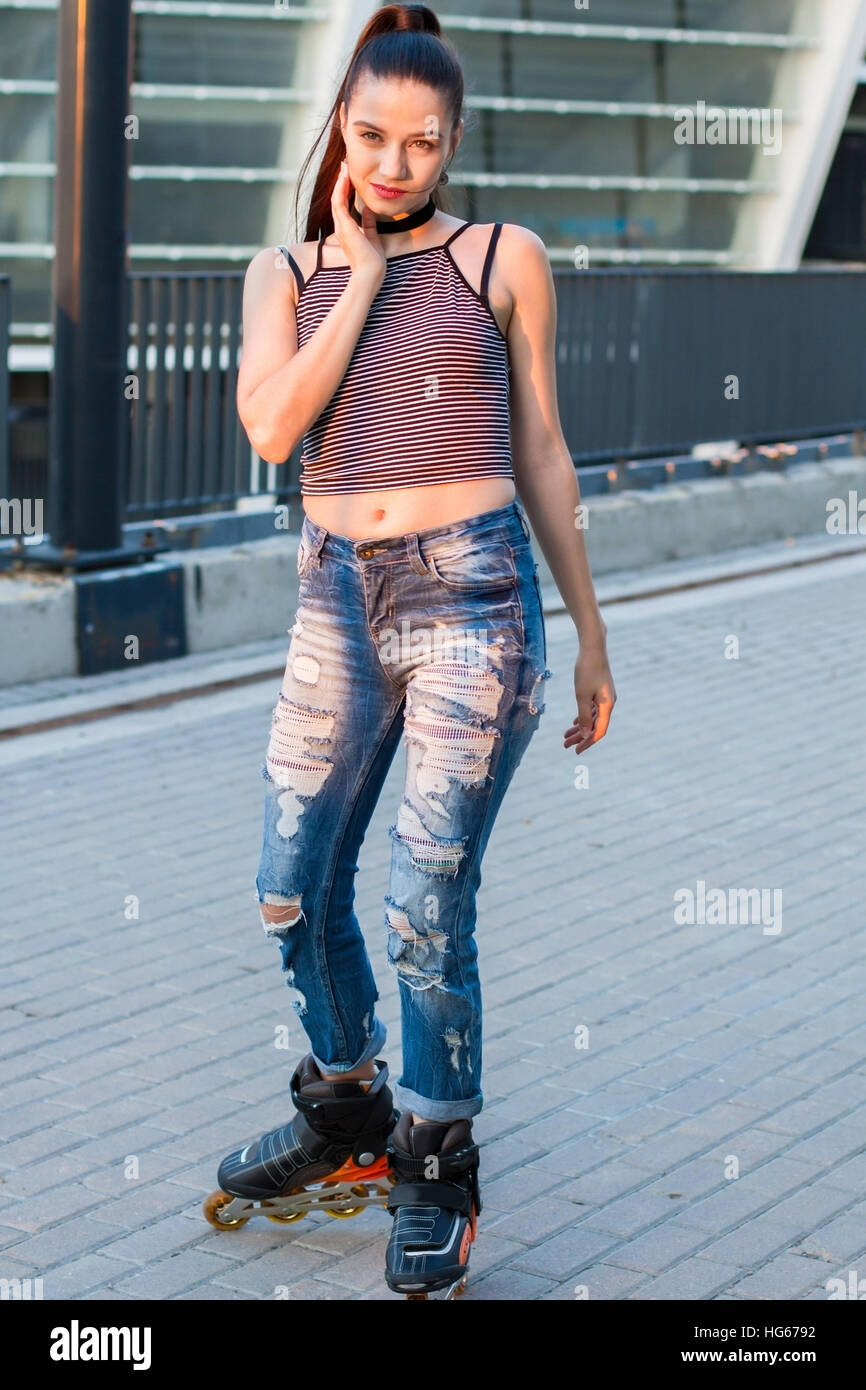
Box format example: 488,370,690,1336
0,268,866,521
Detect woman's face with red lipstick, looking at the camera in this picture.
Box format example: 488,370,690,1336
339,74,463,217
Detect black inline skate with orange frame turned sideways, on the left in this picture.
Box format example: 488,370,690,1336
204,1055,396,1230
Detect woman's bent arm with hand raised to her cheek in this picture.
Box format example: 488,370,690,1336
238,161,386,463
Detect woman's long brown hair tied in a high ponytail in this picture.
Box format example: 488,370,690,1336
295,4,464,242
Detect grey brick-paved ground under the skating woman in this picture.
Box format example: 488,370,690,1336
0,544,866,1300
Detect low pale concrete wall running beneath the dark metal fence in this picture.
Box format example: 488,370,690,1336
0,459,866,685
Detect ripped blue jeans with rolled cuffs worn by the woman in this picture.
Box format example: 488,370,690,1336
256,502,553,1120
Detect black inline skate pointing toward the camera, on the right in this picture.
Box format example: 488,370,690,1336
385,1112,481,1298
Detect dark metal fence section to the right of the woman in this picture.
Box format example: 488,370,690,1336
555,268,866,464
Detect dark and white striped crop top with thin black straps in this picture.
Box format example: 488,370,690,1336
279,222,513,493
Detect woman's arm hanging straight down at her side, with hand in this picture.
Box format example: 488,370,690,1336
499,222,616,753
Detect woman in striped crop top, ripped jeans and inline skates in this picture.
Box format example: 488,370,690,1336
209,4,616,1297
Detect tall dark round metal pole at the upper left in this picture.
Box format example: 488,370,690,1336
49,0,132,563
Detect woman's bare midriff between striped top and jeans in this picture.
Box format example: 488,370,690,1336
302,478,516,541
